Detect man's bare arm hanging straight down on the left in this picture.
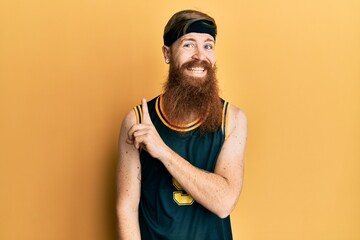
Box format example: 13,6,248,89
116,111,141,240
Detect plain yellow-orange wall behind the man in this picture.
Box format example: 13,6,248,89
0,0,360,240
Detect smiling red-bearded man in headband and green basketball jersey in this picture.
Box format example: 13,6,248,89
117,10,247,240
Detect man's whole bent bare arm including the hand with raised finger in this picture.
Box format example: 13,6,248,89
128,101,247,218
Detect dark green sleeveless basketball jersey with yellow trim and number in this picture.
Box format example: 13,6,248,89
134,95,232,240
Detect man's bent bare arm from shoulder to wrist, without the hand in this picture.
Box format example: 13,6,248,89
160,107,246,218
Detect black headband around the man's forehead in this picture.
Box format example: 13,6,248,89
164,20,216,47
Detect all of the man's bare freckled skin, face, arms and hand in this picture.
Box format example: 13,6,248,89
117,33,247,239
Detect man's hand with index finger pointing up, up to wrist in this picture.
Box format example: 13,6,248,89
126,99,167,159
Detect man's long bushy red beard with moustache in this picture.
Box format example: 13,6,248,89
163,60,222,133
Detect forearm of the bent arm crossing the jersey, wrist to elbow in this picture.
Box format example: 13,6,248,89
160,149,239,218
